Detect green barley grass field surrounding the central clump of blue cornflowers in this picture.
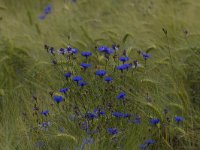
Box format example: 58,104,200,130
0,0,200,150
